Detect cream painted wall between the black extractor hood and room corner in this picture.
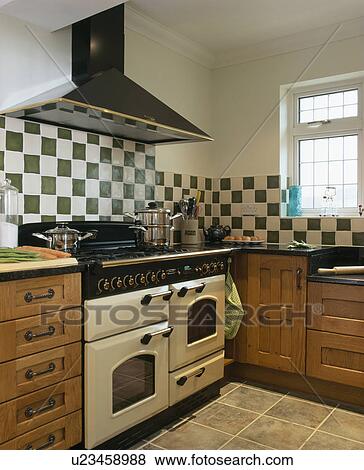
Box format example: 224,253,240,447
125,29,214,176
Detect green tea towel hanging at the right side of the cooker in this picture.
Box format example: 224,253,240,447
225,262,245,339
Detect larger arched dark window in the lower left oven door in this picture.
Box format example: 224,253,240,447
112,354,155,414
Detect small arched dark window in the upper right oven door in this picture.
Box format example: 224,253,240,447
187,298,216,344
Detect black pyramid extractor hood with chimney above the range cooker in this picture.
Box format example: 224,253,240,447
2,5,212,144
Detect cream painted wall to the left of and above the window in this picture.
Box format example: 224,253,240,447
213,36,364,176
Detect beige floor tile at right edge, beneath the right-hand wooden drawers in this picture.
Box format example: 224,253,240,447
320,410,364,442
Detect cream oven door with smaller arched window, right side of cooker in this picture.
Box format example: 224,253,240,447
169,275,225,371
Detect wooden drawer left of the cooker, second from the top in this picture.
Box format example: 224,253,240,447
0,308,81,363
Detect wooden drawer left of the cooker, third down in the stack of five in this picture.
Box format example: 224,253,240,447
0,342,81,403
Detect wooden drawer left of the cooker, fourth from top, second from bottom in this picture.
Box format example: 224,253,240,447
0,377,82,443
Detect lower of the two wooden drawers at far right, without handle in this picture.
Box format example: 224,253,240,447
306,330,364,387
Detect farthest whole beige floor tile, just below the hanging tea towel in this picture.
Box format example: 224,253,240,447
220,385,282,413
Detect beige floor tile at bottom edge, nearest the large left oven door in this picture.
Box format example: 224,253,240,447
153,422,230,450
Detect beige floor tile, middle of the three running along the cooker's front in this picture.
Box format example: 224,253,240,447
194,403,259,434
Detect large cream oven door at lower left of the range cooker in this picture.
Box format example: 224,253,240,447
85,322,171,449
